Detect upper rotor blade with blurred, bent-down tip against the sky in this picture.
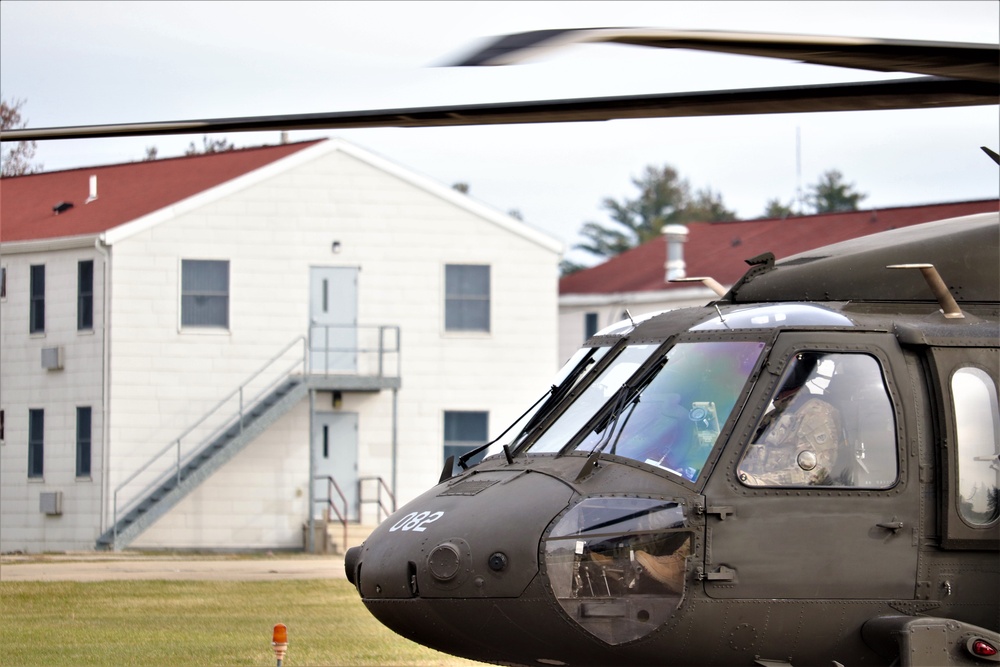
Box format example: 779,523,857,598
455,28,1000,82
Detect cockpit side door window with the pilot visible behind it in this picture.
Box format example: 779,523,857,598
738,352,898,489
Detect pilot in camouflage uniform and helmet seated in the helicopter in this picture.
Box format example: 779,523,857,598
739,360,841,486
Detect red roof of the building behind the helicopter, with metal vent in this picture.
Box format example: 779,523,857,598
559,199,1000,294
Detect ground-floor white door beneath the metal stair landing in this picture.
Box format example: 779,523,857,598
312,412,358,521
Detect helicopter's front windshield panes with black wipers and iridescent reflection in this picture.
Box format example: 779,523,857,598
528,341,764,482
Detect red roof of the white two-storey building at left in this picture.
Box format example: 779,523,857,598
0,140,322,242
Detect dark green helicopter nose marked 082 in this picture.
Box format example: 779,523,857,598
345,470,574,601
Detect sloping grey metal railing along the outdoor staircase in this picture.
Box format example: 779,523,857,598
112,336,308,545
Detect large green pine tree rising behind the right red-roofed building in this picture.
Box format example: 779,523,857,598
575,165,736,258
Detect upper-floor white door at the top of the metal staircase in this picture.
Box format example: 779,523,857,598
309,266,358,373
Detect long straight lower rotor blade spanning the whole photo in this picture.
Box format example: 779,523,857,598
0,77,1000,141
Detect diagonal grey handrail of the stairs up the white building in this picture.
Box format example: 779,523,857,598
112,336,307,544
